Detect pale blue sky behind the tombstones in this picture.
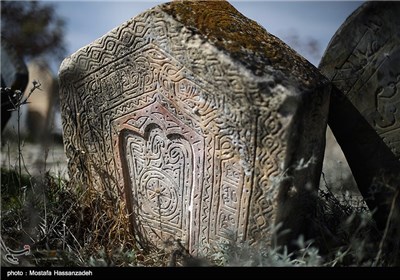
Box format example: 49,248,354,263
46,0,363,71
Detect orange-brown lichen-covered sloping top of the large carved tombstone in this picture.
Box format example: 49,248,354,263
162,1,323,85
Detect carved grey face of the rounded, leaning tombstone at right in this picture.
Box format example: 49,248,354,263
320,2,400,158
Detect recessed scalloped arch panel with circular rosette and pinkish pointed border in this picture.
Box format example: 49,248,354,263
113,102,204,245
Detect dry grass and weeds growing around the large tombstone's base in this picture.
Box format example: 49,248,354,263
1,162,398,267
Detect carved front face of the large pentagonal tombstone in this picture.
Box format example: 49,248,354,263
60,0,326,252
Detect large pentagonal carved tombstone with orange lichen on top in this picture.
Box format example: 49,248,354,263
59,1,330,254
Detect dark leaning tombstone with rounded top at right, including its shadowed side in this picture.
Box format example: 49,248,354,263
319,1,400,229
